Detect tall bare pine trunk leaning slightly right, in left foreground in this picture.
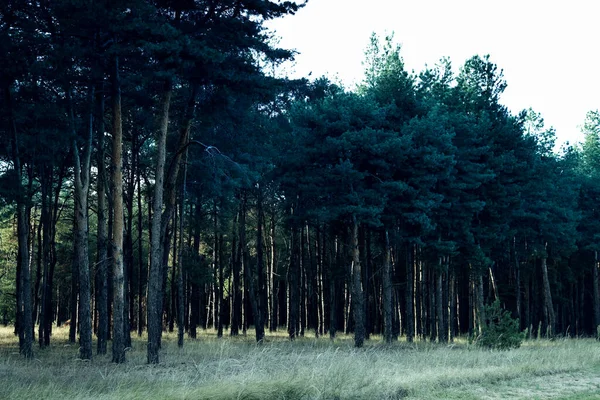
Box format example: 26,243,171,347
147,81,173,364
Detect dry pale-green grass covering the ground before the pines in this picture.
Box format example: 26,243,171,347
0,327,600,400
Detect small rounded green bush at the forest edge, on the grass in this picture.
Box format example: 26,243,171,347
477,300,523,350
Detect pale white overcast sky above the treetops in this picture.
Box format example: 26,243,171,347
267,0,600,144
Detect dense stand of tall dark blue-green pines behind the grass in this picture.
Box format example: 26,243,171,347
0,0,600,363
